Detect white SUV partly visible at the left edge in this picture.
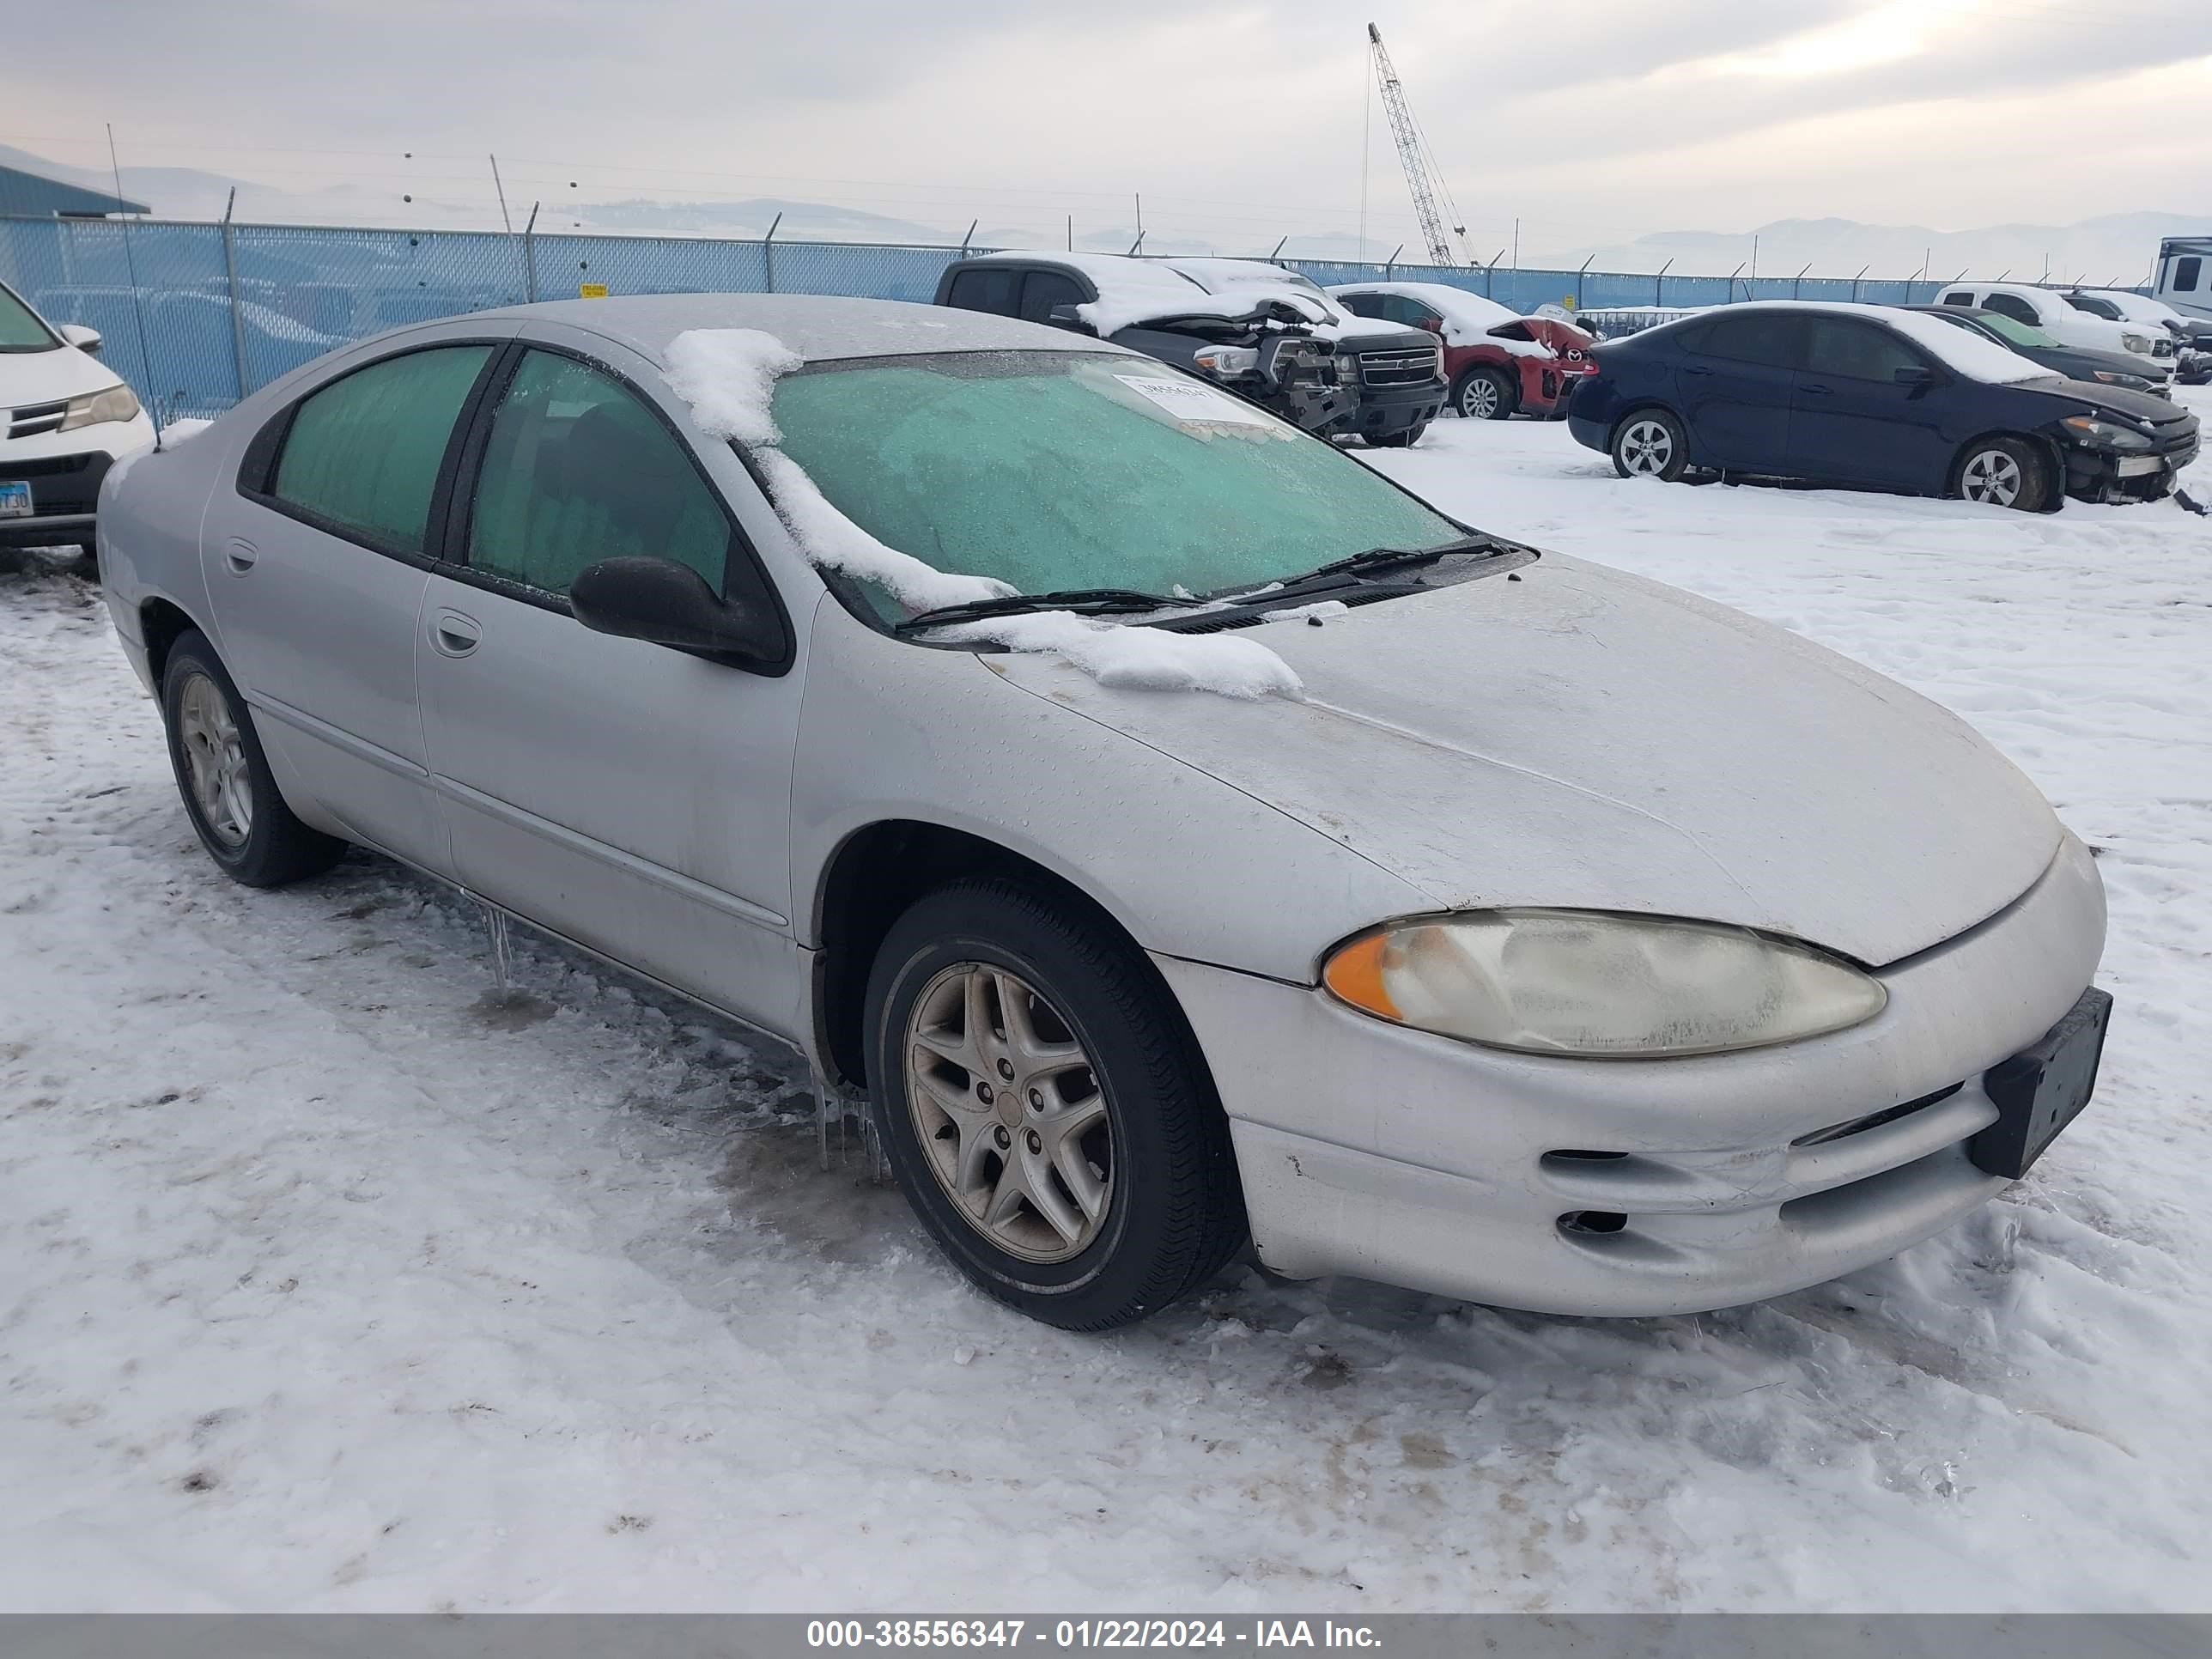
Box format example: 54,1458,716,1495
0,283,153,546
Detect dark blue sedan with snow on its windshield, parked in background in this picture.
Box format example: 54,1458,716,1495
1568,301,2197,511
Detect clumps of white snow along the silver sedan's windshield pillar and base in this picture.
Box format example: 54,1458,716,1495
668,327,1305,696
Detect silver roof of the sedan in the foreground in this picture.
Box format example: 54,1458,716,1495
476,295,1124,362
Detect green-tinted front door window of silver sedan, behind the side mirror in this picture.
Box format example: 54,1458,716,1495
469,352,730,592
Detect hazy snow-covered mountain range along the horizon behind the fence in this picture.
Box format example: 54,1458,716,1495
0,143,2212,285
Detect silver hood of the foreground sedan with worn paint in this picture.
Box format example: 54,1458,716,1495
994,556,2062,967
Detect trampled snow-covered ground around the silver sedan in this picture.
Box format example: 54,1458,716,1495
13,394,2212,1610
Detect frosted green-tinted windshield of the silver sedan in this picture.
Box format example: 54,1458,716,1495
775,352,1462,619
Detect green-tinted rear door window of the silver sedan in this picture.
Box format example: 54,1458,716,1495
270,345,491,553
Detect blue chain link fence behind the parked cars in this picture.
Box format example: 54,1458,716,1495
0,216,1940,422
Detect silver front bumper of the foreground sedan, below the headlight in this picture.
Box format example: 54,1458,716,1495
1157,836,2104,1316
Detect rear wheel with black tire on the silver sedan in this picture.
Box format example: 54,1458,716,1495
161,630,345,887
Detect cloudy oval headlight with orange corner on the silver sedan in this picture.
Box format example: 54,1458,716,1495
1321,909,1889,1060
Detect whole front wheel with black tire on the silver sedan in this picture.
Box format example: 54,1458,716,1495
865,878,1248,1332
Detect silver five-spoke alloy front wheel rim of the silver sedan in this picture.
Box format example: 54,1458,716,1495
905,963,1115,1263
